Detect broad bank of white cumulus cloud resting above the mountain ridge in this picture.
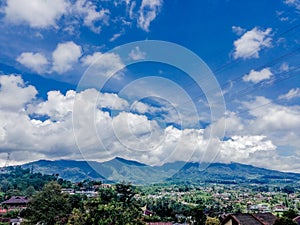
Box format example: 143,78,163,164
0,75,300,170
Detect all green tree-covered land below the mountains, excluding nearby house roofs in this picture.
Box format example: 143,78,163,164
0,164,300,225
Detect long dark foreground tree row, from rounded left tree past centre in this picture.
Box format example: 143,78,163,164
15,181,206,225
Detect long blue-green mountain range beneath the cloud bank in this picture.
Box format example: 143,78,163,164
22,157,300,184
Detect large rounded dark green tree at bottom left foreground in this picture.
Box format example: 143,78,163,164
25,181,71,225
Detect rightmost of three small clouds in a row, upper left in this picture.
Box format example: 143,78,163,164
81,52,125,77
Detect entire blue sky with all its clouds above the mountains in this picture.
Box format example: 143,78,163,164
0,0,300,172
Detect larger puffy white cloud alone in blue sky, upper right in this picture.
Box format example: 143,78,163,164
233,27,272,59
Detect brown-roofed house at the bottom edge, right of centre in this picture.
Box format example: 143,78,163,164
221,213,277,225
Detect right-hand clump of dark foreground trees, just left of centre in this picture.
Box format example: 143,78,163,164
68,183,144,225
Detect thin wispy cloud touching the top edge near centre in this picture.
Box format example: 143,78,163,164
138,0,163,32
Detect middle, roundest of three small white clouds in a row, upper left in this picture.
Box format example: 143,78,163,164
52,41,82,74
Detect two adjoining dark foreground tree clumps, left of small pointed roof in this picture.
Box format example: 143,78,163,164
20,182,144,225
